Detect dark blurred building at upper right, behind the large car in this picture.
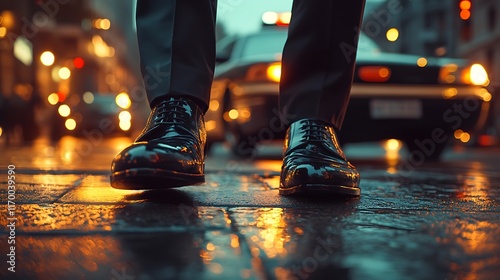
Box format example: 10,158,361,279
363,0,500,81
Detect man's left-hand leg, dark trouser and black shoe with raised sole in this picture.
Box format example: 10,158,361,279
110,0,216,189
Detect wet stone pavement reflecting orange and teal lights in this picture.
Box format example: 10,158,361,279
0,138,500,280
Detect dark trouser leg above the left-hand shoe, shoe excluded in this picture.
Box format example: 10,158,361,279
136,0,217,110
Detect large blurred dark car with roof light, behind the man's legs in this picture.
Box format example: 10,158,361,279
205,12,492,160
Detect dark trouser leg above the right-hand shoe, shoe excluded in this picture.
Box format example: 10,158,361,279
280,0,365,129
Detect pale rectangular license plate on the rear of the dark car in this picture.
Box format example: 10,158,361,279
370,99,422,119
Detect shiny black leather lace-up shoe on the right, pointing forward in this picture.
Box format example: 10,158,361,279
279,119,360,196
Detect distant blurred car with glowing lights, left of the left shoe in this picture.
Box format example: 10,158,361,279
48,91,132,139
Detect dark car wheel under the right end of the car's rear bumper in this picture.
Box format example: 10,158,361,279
403,138,448,164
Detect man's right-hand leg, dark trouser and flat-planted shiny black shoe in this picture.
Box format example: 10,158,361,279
280,0,365,196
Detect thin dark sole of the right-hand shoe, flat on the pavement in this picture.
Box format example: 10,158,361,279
279,184,361,197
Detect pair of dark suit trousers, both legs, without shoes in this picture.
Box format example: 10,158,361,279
137,0,365,128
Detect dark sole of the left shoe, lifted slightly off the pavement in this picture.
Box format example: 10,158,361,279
110,168,205,190
